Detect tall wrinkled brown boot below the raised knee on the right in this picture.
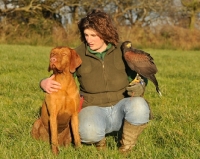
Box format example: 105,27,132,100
119,120,147,153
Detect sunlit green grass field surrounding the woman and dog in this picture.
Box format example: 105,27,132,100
0,45,200,159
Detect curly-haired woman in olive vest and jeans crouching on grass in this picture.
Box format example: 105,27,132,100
41,10,150,152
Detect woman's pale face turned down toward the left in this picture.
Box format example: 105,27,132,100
84,29,107,52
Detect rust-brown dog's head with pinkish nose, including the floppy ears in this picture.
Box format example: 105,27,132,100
48,47,82,73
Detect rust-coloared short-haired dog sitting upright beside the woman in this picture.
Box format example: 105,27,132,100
31,47,82,154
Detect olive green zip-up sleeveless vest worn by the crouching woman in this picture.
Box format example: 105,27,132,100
76,43,136,107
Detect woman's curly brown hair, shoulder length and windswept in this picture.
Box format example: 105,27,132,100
78,9,119,46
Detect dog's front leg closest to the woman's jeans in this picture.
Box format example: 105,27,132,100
71,113,81,148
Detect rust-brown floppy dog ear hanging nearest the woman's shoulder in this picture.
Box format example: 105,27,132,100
69,49,82,73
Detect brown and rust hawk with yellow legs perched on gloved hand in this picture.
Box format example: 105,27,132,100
121,41,162,96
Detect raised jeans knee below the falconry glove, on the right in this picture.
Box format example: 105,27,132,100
124,97,150,125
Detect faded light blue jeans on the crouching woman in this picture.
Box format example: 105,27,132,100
79,97,150,143
